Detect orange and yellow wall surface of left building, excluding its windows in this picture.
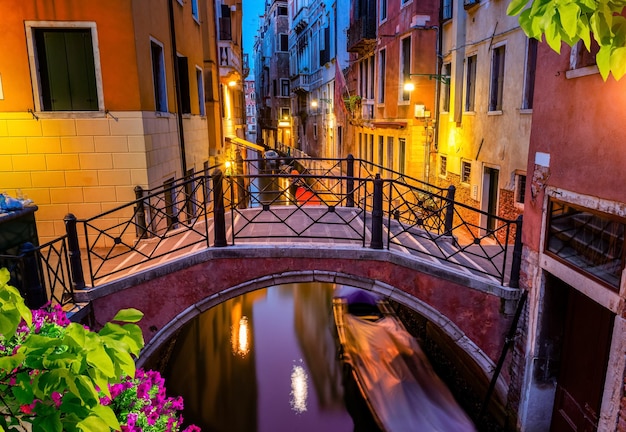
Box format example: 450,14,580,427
0,0,217,242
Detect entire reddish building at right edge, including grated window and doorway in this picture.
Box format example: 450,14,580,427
518,38,626,431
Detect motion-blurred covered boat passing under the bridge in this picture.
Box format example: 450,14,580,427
333,287,476,432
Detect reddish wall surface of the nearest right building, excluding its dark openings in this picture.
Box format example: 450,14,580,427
520,38,626,430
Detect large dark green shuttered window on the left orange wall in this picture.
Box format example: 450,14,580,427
32,28,99,111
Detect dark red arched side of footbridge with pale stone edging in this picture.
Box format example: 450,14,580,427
76,244,519,400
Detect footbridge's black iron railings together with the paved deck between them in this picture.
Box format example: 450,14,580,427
7,154,521,304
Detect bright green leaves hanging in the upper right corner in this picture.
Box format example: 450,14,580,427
507,0,626,81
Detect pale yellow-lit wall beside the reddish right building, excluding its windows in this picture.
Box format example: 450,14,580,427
430,1,532,224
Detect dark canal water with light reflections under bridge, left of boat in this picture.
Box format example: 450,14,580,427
158,283,377,432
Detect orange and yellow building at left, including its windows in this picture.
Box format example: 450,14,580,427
0,0,223,241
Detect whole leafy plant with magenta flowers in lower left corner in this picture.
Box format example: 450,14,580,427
0,269,199,432
